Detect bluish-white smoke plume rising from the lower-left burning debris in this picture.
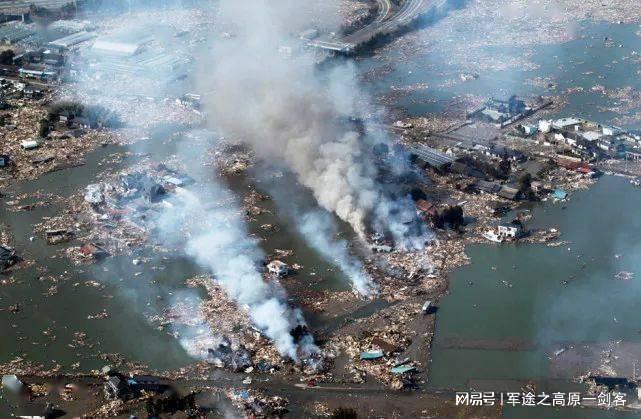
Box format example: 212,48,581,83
159,187,317,360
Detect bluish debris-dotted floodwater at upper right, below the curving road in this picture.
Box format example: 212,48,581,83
358,23,641,129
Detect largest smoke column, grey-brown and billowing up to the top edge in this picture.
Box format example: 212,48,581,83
201,0,430,248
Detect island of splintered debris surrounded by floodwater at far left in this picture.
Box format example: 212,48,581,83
36,164,193,263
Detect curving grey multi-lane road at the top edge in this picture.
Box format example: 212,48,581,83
307,0,446,53
